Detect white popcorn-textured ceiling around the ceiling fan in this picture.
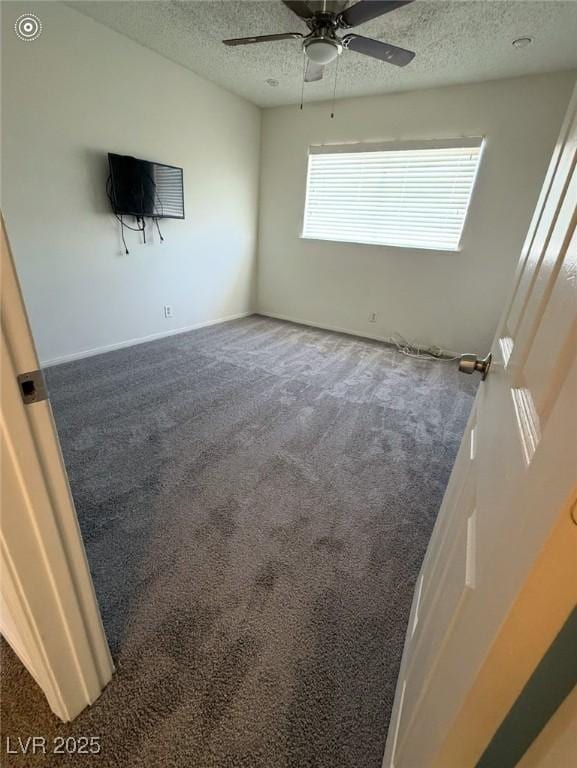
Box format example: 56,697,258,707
68,0,577,107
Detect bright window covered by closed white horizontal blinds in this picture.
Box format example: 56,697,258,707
303,139,483,251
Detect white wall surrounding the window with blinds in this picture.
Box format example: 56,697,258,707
257,73,575,354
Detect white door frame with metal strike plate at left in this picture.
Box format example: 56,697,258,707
0,217,113,720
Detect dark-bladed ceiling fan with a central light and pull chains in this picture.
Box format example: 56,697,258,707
222,0,415,83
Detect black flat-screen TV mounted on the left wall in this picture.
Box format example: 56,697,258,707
108,152,184,219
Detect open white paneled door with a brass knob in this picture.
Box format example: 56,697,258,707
383,89,577,768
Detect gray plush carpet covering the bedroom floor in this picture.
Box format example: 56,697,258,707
2,316,475,768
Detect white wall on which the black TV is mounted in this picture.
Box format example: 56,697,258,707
2,2,260,362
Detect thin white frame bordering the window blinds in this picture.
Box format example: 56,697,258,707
299,136,487,253
